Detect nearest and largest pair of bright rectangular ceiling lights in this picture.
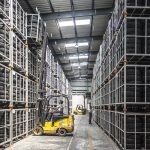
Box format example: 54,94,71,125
59,19,90,27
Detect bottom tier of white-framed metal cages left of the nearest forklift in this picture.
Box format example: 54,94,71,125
0,108,35,148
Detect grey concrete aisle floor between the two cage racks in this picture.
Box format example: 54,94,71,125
7,116,118,150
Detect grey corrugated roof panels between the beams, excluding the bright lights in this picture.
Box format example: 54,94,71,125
19,0,114,79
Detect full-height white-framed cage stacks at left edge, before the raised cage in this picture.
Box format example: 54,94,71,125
0,0,29,148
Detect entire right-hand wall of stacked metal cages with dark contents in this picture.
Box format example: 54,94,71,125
92,0,150,150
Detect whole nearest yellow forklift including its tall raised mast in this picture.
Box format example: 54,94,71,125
33,31,74,136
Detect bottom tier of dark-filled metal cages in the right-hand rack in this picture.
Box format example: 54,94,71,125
96,110,150,150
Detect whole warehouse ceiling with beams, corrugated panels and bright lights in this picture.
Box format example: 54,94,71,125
19,0,114,80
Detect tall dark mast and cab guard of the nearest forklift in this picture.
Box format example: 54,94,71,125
36,30,69,125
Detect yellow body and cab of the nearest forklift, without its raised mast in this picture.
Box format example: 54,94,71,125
33,95,74,136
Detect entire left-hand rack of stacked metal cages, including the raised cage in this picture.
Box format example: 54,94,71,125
0,0,72,149
